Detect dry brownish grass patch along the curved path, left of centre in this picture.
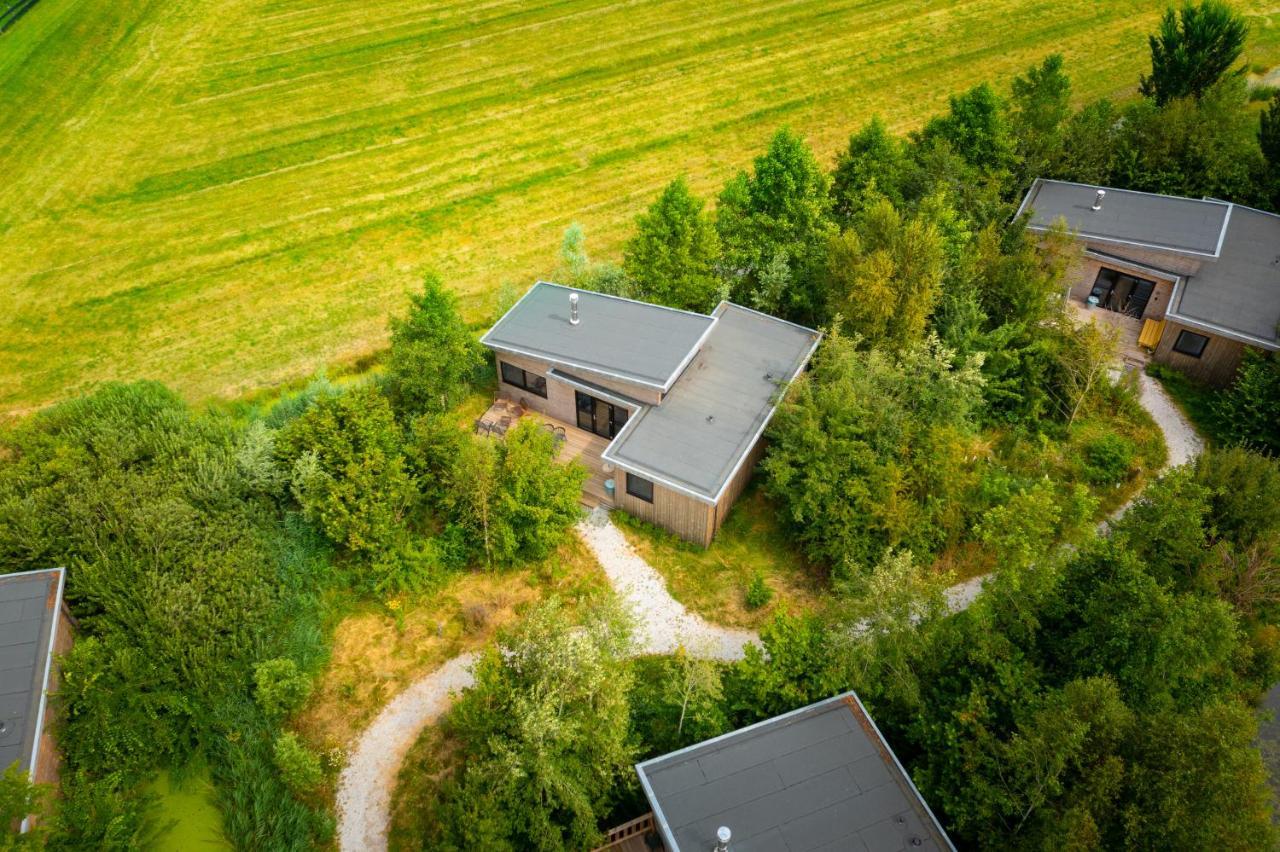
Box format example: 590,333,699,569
293,536,608,750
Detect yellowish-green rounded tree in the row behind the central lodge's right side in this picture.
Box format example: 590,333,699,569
827,198,946,352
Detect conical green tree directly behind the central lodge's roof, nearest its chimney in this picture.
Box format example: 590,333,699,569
622,178,722,312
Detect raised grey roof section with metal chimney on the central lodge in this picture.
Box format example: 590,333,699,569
480,281,713,390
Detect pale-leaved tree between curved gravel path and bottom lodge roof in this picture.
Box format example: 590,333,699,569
431,600,634,849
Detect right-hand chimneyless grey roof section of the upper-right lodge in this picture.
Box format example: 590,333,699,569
1172,205,1280,349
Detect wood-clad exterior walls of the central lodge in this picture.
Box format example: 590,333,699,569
495,352,764,548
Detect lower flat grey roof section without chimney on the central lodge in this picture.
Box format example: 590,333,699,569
604,302,819,501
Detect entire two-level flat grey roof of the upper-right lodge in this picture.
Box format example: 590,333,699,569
1019,179,1280,349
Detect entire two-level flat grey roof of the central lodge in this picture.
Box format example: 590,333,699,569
481,281,820,503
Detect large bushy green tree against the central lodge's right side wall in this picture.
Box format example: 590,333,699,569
763,333,982,573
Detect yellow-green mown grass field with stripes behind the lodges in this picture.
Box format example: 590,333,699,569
0,0,1280,413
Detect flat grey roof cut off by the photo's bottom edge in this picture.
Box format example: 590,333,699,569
636,692,955,852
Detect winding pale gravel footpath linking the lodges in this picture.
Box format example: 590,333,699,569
337,365,1204,852
